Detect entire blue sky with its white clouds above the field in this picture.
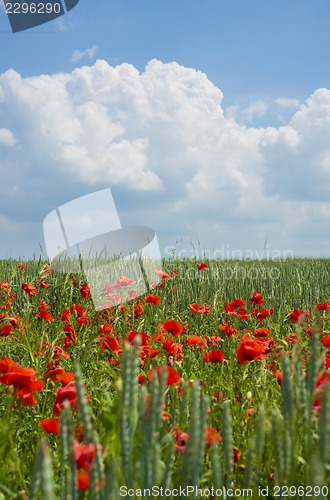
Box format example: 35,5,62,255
0,0,330,258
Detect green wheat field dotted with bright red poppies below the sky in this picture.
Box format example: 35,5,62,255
0,259,330,500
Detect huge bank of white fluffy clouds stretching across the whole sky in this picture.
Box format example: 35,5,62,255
0,60,330,260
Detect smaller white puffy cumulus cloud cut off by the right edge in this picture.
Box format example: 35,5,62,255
260,89,330,202
